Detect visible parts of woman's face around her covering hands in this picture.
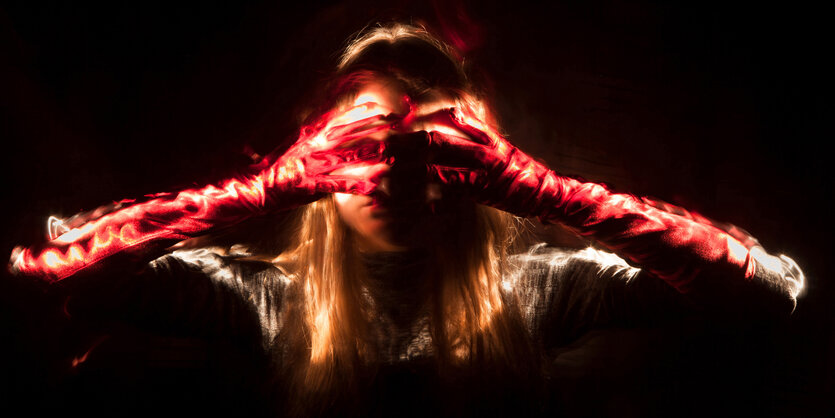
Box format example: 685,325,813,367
333,82,452,252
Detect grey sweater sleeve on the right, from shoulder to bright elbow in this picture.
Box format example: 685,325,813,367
505,244,802,347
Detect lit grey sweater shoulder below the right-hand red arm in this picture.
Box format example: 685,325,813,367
510,244,689,344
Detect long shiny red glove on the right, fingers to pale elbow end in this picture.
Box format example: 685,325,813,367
412,110,802,297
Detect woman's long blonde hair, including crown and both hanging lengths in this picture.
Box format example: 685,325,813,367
276,25,535,408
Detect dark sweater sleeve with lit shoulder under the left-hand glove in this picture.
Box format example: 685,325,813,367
62,249,287,348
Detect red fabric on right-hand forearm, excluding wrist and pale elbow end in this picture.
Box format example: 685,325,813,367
539,177,754,292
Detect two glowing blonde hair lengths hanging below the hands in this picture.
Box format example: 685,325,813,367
277,197,532,393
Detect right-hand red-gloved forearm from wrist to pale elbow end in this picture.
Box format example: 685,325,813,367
536,170,803,307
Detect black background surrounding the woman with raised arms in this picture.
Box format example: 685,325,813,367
0,1,835,416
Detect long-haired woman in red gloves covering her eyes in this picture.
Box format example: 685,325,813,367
6,25,803,415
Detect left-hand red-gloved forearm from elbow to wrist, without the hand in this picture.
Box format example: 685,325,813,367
10,171,293,281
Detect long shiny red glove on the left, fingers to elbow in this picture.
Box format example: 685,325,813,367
9,104,392,281
